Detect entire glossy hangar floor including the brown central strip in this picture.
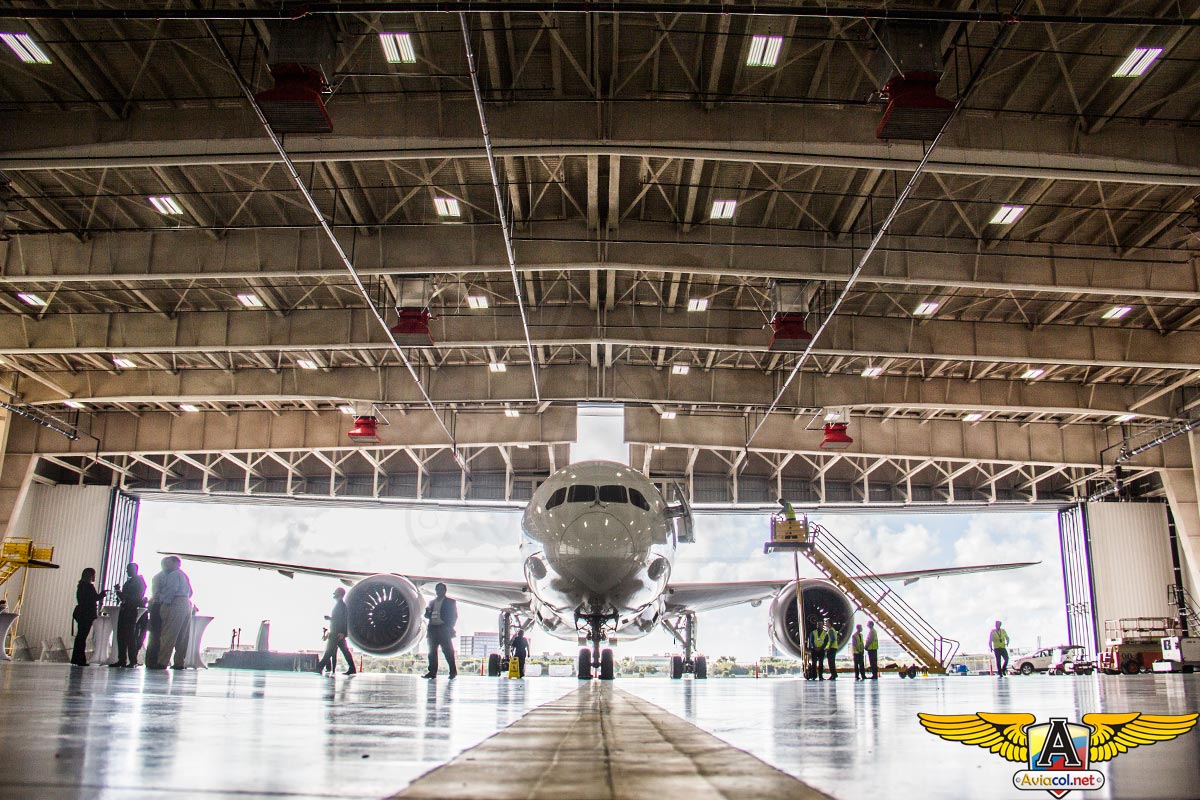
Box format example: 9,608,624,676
0,663,1200,800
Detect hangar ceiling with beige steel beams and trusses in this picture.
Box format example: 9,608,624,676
0,0,1200,503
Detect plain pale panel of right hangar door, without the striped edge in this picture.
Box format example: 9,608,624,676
1087,503,1175,639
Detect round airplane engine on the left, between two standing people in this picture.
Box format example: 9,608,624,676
346,575,425,656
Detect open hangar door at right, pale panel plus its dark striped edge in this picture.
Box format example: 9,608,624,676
1058,503,1186,656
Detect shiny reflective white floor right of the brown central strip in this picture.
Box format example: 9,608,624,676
619,675,1200,800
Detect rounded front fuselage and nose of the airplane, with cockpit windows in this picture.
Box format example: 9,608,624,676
521,461,676,639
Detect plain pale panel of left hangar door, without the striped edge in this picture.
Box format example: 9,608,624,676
6,483,112,658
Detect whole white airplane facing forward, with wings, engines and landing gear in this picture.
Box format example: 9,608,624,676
170,461,1036,680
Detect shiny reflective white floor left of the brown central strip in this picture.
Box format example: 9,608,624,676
0,663,577,800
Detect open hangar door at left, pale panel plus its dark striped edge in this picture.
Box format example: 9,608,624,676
6,482,138,658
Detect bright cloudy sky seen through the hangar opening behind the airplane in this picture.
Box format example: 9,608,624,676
136,407,1066,660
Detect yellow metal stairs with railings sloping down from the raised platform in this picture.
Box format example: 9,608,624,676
800,523,959,673
